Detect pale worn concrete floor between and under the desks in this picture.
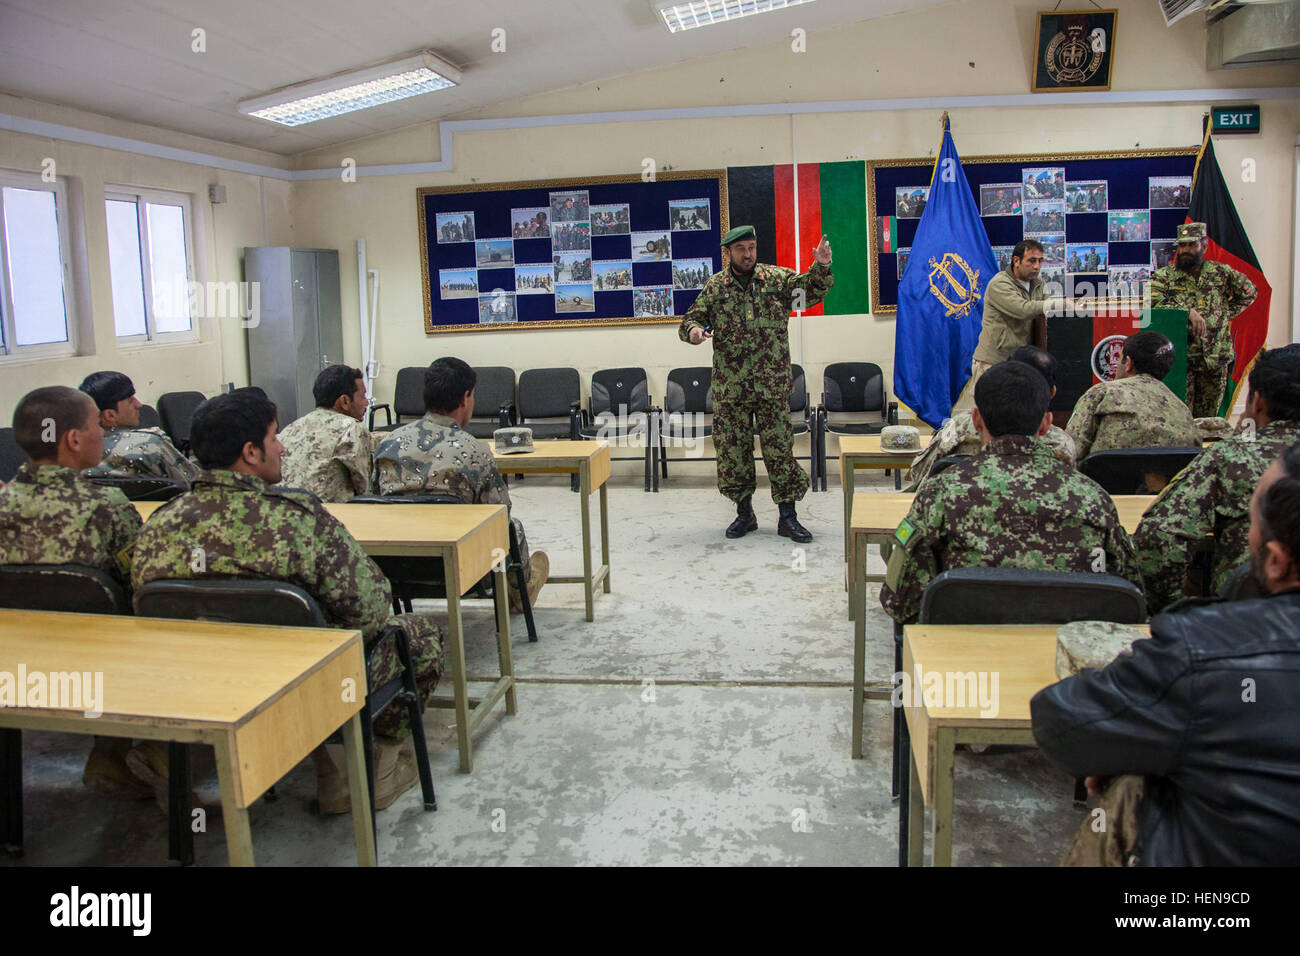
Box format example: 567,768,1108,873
0,463,1084,866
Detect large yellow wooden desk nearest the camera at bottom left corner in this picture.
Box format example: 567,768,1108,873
0,610,376,866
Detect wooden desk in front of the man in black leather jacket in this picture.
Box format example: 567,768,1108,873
898,624,1148,866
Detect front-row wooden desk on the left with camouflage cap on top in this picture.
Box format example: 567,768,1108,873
493,441,610,620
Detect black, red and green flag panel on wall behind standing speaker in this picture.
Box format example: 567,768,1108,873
727,163,871,315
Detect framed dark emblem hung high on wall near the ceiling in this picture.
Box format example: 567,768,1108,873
1032,9,1119,92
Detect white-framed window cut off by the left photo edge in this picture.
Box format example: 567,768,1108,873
0,169,77,359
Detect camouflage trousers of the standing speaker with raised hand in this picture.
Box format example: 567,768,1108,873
714,398,809,505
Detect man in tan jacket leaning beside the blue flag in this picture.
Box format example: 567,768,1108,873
970,239,1074,385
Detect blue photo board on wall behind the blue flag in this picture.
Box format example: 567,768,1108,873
867,146,1197,312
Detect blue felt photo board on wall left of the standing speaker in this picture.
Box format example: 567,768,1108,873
416,169,728,333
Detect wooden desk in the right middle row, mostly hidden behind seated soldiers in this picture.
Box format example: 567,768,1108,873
849,492,1156,760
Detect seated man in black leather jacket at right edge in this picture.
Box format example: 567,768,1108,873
1030,445,1300,866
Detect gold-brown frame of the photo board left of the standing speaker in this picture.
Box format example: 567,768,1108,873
415,169,731,336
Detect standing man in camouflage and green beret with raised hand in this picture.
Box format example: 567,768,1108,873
677,226,835,541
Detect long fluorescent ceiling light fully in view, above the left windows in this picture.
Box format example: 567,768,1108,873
238,51,460,126
